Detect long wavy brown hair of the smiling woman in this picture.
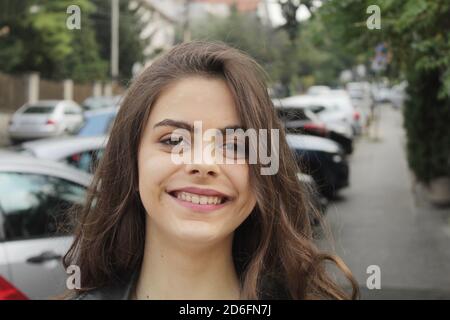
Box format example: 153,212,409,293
64,41,358,299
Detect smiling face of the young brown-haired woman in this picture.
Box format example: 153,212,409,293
138,77,256,245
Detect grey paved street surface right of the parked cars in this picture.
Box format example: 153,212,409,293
318,105,450,299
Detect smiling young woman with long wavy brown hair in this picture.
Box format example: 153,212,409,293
64,42,358,299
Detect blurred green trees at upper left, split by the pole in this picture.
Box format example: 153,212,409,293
0,0,143,82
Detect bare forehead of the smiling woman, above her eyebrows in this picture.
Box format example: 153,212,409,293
149,76,239,128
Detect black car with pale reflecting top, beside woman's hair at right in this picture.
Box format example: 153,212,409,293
286,134,350,199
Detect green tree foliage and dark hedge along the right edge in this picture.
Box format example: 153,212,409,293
320,0,450,182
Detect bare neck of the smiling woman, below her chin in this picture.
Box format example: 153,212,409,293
135,221,240,300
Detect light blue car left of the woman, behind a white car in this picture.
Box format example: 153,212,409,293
75,107,119,137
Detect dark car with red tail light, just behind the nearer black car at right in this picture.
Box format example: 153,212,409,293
274,100,353,154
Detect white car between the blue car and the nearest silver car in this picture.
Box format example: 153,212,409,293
9,136,108,173
